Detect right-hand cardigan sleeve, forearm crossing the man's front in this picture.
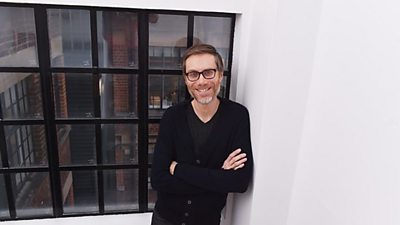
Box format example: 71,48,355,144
174,107,253,193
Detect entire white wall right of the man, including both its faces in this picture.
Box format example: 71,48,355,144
232,0,400,225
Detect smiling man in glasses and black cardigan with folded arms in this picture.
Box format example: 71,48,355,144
151,44,253,225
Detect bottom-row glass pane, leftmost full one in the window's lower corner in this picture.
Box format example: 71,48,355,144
11,172,53,217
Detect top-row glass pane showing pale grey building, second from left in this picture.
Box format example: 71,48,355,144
47,9,92,67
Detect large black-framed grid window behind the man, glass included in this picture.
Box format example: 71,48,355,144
0,3,235,220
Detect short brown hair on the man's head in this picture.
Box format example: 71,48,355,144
182,44,224,74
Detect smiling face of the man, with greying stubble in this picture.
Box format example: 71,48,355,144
185,54,223,104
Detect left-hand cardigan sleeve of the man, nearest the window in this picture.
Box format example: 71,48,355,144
151,110,206,194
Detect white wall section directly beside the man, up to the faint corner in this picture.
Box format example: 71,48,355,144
232,0,321,225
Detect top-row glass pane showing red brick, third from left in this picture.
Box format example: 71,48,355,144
97,12,139,68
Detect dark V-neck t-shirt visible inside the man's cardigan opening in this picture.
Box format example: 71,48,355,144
186,105,219,155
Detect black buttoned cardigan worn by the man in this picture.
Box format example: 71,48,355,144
151,99,253,225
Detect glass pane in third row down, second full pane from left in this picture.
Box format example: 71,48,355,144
57,124,96,165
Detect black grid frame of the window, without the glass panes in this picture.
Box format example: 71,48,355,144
0,3,236,221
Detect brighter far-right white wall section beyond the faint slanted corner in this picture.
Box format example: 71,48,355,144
288,0,400,225
